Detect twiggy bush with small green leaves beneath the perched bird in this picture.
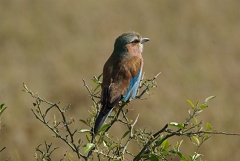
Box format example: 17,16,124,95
23,74,239,161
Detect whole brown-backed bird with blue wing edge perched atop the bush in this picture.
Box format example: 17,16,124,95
93,31,149,134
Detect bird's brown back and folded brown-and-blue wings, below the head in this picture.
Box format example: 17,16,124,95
102,56,143,107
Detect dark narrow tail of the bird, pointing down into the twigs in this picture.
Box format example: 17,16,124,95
93,108,113,134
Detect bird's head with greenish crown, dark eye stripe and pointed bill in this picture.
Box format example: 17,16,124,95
114,32,149,52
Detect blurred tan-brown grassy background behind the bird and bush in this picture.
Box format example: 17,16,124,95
0,0,240,161
